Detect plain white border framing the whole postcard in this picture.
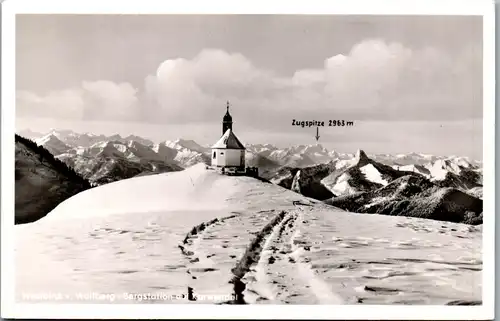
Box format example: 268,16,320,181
1,0,495,320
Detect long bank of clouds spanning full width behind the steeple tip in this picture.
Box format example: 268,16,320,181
17,39,482,130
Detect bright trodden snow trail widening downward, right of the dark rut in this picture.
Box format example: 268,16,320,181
244,206,343,304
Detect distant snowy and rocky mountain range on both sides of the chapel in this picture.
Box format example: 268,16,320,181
16,130,482,222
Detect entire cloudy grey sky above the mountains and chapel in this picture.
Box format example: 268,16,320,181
16,15,483,159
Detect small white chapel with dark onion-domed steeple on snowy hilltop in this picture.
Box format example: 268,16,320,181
212,102,245,170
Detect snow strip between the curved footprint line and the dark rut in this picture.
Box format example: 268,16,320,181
173,210,286,303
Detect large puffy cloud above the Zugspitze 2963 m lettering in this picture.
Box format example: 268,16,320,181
294,40,482,120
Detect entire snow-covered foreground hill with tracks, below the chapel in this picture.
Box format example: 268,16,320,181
16,164,482,304
